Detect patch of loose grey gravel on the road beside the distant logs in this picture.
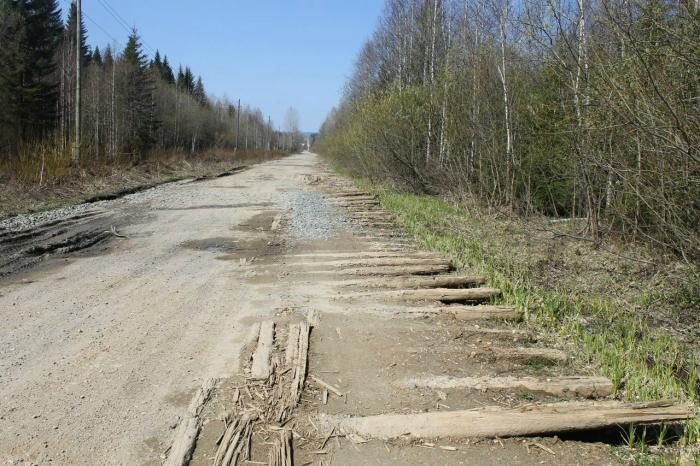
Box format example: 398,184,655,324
285,191,353,240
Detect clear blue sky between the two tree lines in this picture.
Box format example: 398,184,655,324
65,0,384,131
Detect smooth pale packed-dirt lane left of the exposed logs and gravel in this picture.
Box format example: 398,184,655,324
0,156,312,464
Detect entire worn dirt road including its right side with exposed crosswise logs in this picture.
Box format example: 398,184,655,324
0,154,686,464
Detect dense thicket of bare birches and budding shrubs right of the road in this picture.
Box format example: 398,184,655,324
315,0,700,262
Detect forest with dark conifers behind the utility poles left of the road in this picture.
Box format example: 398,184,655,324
0,0,301,185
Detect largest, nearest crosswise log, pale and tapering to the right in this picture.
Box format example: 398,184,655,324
330,401,695,439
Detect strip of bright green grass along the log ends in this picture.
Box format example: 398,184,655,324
357,180,700,452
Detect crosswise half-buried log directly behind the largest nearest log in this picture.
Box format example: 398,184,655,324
403,376,613,398
